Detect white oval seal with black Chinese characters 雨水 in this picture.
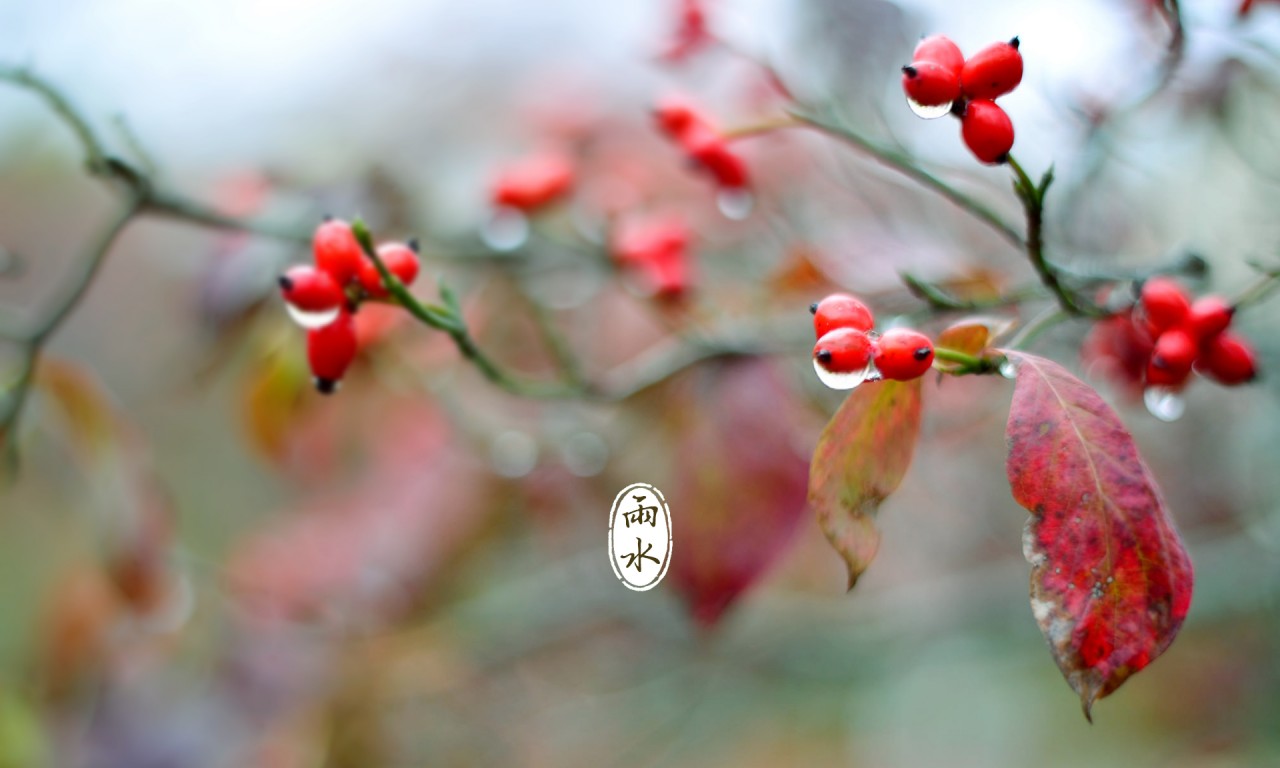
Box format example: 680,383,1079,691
609,483,672,591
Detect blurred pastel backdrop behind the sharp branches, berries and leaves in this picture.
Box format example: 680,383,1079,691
0,0,1280,768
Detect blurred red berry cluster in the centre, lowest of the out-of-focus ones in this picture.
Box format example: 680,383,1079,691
609,214,692,300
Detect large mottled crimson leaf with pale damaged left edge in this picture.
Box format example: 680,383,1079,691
1006,352,1193,721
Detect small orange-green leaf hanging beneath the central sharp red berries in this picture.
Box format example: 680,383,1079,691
809,379,920,589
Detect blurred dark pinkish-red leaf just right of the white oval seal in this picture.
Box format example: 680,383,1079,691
669,360,805,625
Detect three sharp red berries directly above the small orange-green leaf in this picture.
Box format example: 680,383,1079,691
809,293,933,381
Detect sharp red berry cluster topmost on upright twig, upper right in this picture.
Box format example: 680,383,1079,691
902,35,1023,164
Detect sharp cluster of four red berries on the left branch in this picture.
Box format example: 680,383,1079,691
279,219,419,394
